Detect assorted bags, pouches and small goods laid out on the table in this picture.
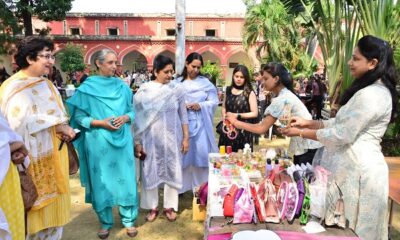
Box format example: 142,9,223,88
210,149,332,229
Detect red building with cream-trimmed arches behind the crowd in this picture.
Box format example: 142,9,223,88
47,13,259,82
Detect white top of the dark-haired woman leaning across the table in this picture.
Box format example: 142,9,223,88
264,88,321,155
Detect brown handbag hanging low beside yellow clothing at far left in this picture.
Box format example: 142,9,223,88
18,164,39,212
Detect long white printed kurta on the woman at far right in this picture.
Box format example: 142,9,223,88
314,81,392,240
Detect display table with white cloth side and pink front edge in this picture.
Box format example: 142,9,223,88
204,153,358,240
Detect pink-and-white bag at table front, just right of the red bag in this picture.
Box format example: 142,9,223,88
233,188,254,223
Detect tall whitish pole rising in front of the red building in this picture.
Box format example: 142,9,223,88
175,0,186,74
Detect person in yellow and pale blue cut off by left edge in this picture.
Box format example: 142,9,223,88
0,113,28,240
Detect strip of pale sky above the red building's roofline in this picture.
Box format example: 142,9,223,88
71,0,246,14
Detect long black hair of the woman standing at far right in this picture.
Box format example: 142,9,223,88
339,35,398,122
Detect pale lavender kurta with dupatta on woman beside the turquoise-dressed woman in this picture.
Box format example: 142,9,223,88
135,81,190,189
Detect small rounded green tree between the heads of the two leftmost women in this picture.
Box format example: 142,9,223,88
57,43,86,81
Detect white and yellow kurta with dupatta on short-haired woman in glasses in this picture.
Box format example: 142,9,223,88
0,71,70,234
